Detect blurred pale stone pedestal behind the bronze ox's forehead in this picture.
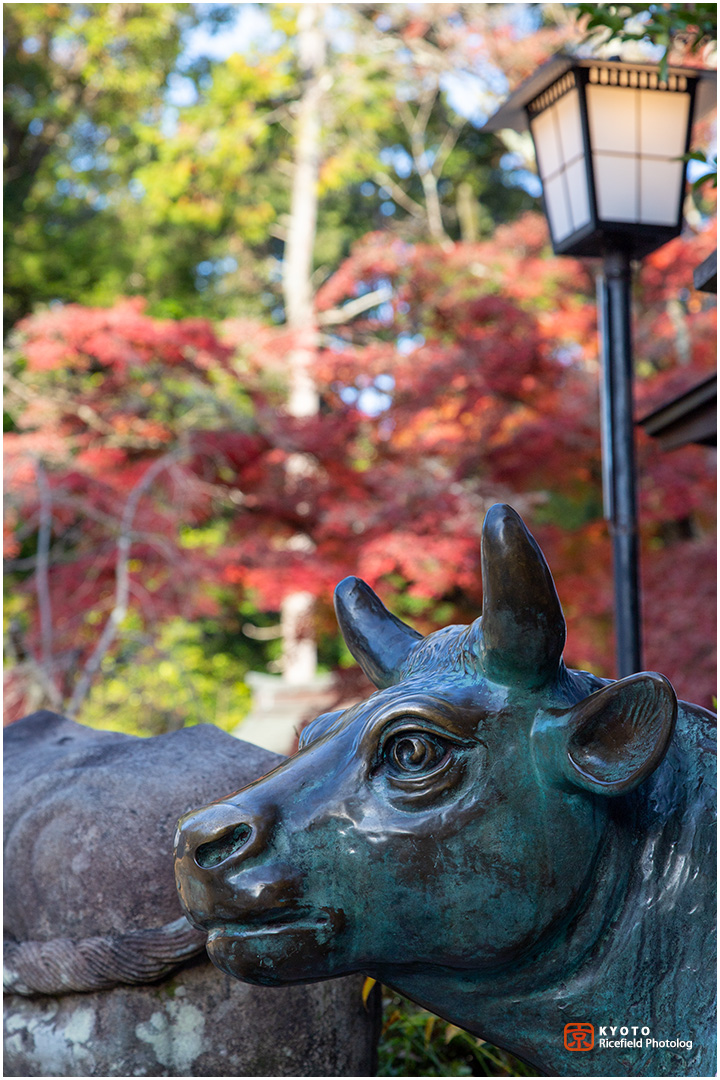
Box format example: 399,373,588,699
232,672,336,754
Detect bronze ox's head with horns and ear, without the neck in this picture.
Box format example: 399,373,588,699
176,505,677,993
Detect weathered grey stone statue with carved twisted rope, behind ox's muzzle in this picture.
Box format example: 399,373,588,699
3,712,377,1077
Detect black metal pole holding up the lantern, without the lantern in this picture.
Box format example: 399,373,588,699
598,252,642,678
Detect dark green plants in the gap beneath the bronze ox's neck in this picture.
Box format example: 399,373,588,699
378,990,536,1077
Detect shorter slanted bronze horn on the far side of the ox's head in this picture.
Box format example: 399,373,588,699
335,578,422,689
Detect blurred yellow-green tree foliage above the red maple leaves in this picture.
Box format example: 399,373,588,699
4,3,546,327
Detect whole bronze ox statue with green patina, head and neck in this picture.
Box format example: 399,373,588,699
176,505,716,1077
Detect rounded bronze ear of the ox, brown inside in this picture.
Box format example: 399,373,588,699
562,672,678,795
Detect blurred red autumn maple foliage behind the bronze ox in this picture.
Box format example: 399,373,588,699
5,215,715,710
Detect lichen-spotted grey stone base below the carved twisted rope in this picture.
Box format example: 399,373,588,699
3,959,380,1077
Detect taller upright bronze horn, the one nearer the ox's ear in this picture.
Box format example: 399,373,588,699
481,503,566,686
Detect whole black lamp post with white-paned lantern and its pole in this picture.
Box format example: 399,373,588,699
484,54,715,678
